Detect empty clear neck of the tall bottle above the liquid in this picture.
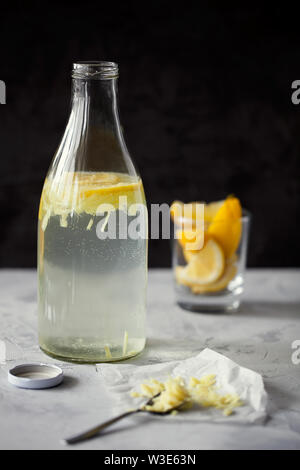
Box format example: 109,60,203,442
53,62,135,174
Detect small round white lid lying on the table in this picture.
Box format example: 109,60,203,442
8,363,64,389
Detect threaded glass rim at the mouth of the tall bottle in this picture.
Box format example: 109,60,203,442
72,60,119,80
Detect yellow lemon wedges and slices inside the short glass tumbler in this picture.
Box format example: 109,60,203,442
170,196,242,294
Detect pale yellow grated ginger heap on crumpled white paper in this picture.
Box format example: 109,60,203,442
131,374,243,416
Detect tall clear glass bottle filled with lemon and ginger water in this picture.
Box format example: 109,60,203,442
38,62,147,362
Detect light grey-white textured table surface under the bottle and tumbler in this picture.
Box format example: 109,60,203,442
0,269,300,450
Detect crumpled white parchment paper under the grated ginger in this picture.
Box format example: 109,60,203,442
97,348,267,423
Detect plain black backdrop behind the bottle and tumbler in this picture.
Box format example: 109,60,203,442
0,0,300,267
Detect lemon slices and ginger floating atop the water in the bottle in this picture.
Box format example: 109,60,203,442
39,172,145,231
